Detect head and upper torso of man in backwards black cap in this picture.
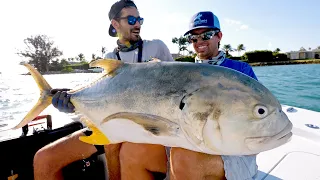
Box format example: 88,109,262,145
106,0,173,63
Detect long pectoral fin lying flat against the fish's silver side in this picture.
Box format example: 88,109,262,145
101,112,180,136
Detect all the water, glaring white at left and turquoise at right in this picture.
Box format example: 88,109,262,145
0,64,320,131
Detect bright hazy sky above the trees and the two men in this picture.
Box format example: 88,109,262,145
0,0,320,71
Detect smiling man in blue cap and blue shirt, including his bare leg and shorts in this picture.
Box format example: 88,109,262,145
171,11,258,180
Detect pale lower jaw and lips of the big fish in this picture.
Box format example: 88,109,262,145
245,121,293,149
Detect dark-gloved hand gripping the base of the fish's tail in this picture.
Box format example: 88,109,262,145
50,89,74,113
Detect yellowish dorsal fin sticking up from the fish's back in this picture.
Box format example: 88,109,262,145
90,59,124,74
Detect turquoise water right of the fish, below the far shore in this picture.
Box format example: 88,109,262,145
253,64,320,112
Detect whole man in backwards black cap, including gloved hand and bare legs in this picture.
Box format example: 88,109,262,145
34,0,174,180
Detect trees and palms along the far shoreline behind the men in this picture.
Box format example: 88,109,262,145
17,35,320,73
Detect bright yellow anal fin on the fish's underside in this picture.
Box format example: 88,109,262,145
79,117,110,145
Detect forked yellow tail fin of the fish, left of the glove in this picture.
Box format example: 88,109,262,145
13,63,52,129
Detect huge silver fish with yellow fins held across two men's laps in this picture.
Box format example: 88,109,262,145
10,59,292,155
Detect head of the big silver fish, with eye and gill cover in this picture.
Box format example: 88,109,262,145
181,69,292,155
